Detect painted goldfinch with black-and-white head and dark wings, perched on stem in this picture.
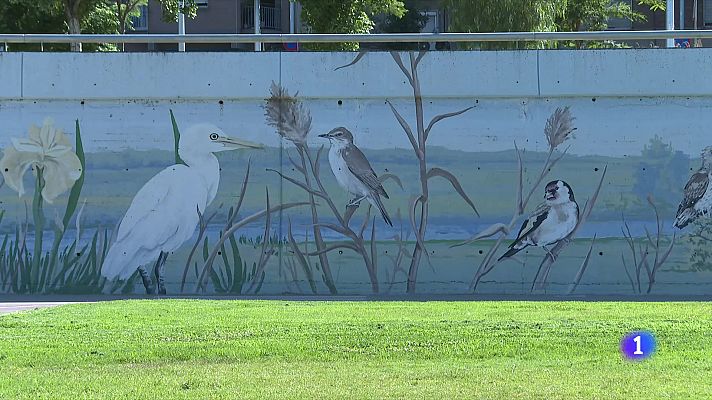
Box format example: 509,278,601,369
498,180,579,261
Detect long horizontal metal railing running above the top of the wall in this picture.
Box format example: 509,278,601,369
0,30,712,43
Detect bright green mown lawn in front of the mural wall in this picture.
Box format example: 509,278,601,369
0,300,712,399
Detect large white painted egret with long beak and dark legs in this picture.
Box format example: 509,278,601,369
101,124,262,294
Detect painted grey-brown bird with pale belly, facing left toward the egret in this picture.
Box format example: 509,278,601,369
319,127,393,226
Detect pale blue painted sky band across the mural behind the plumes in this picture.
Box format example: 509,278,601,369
0,95,712,157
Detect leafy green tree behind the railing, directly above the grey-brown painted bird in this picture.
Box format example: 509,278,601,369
300,0,405,50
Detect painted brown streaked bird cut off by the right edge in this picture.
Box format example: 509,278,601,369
675,146,712,229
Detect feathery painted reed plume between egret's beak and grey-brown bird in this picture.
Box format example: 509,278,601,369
264,82,311,145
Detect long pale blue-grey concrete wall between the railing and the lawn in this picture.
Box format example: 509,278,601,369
0,49,712,294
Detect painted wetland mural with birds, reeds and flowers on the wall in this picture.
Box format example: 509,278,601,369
0,52,712,295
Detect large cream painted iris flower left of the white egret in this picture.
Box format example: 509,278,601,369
0,118,82,203
